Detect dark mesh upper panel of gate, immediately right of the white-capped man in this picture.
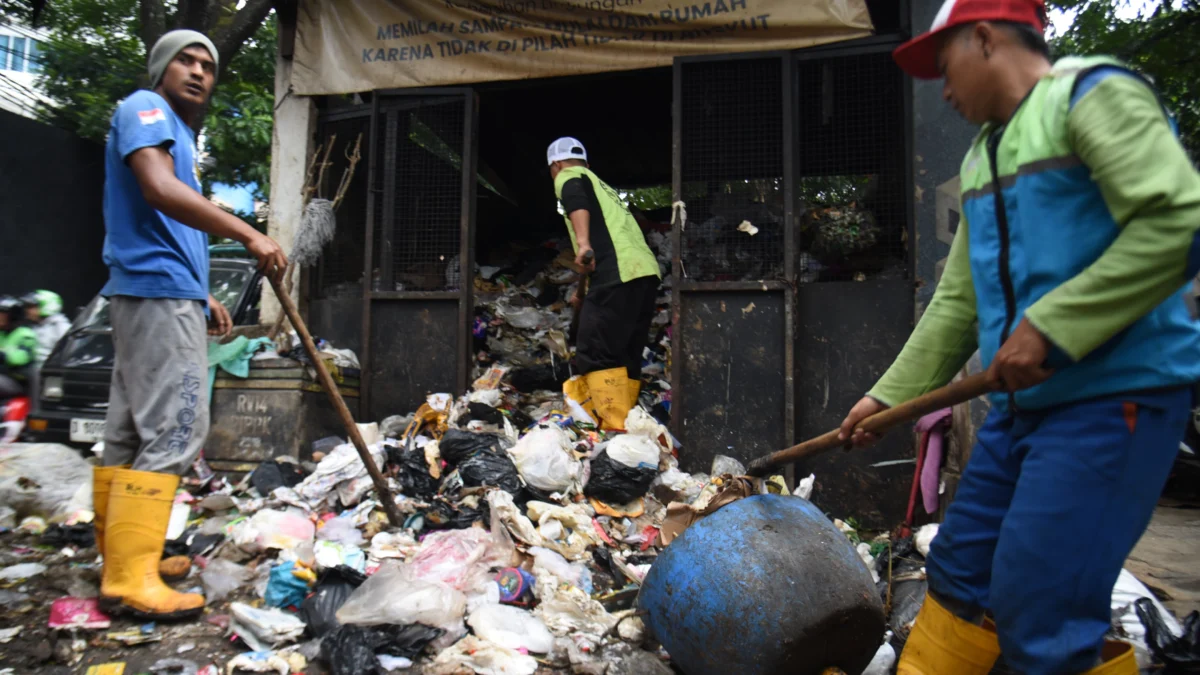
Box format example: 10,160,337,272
678,58,785,281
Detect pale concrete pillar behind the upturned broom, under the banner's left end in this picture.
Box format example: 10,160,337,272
259,42,317,325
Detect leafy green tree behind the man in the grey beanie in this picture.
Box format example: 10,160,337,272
0,0,276,196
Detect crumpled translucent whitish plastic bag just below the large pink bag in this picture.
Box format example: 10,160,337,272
337,561,467,633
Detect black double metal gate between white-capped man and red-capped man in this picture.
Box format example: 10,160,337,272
671,38,914,525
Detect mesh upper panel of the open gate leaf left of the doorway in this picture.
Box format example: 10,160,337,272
377,97,469,292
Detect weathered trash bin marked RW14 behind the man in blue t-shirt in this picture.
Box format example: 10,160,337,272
204,358,359,473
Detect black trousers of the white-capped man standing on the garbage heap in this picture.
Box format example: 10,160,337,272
575,276,659,380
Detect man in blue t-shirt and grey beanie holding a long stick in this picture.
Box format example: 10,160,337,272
92,30,287,620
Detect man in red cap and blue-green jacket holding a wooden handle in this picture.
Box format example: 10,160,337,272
842,0,1200,675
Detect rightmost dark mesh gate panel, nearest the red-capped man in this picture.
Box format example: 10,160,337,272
796,52,910,283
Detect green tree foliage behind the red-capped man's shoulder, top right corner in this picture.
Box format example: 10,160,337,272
1049,0,1200,162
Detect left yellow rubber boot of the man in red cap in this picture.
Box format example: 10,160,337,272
896,593,1000,675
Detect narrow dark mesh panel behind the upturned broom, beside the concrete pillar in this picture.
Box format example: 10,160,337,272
313,112,371,298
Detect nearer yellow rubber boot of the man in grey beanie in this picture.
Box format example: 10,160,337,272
100,468,204,620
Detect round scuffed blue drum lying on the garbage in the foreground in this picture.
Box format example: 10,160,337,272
638,487,884,675
